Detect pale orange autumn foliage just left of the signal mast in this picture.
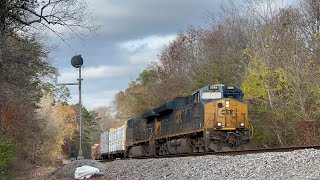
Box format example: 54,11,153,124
36,94,77,162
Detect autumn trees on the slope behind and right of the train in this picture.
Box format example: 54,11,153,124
114,0,320,147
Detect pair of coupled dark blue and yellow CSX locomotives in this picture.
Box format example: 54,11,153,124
94,84,250,157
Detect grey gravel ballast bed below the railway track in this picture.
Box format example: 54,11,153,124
48,149,320,180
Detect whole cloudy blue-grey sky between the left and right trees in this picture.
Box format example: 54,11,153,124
48,0,221,110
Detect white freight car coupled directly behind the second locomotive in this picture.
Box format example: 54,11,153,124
109,125,126,158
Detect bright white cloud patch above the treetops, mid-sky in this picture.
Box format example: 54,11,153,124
119,35,176,65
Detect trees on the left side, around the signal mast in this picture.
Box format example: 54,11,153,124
0,0,98,177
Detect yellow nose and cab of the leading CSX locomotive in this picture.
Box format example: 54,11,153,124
197,84,250,151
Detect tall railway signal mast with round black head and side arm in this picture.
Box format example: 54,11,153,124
56,55,84,159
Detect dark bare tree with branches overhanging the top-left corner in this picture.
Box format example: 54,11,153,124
0,0,97,131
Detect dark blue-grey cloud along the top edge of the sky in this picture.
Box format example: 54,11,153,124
88,0,221,39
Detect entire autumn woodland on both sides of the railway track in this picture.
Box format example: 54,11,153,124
0,0,320,175
